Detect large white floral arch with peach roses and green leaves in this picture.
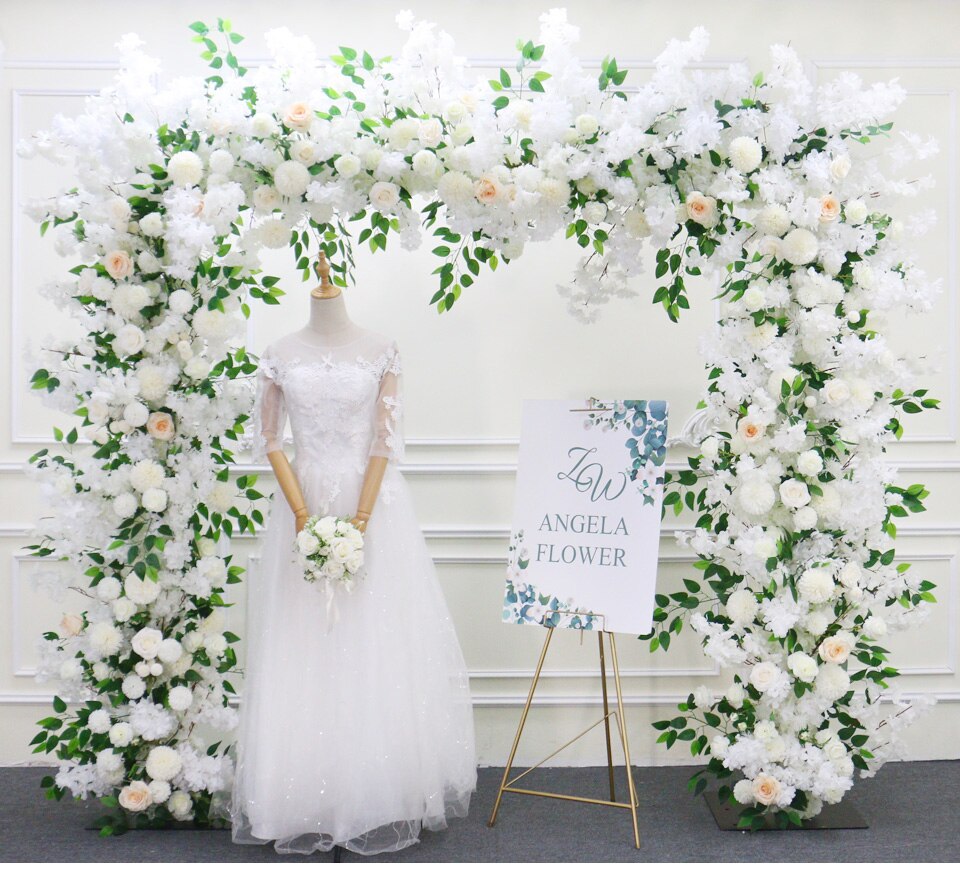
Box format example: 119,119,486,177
22,10,937,832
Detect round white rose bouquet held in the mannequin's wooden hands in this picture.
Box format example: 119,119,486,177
297,515,363,602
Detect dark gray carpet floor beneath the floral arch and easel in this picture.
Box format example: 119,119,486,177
0,761,960,863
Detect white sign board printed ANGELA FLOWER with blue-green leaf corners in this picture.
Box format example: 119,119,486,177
503,400,667,634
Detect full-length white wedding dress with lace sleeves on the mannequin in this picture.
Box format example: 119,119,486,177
230,331,477,854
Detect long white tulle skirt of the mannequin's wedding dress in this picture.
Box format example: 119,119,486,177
230,464,477,854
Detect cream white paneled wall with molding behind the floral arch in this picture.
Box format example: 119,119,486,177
0,0,960,764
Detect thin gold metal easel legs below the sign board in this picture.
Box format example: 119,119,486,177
487,627,640,849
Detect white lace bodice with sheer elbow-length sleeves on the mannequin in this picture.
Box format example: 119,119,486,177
253,331,403,496
